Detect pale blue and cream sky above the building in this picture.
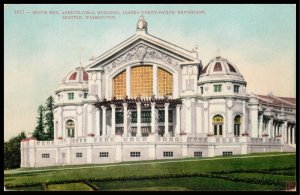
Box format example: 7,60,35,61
4,4,296,140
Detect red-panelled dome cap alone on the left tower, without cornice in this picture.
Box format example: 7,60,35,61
62,67,89,84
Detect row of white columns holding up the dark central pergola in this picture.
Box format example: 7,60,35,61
97,102,181,137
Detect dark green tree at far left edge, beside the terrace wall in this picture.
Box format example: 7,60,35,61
4,131,26,169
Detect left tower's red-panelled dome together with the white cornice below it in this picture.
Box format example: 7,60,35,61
56,67,89,93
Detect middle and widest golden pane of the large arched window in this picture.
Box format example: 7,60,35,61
131,65,153,97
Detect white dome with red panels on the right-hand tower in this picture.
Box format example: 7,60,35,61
199,56,246,83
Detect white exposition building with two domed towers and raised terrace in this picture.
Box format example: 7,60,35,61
21,17,296,167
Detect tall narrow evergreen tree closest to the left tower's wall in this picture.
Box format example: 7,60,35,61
45,96,54,140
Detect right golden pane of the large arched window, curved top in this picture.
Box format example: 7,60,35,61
157,68,173,97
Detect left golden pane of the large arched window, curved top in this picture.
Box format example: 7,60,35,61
113,71,126,99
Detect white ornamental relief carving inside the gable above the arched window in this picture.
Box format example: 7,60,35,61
106,44,178,72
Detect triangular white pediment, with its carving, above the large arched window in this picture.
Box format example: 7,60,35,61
86,32,200,72
